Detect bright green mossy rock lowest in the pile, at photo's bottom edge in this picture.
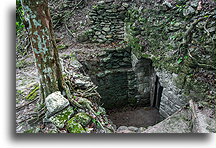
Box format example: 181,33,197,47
66,119,86,133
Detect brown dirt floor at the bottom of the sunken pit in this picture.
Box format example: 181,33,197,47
107,107,162,127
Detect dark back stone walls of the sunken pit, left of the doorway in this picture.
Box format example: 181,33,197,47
81,47,151,109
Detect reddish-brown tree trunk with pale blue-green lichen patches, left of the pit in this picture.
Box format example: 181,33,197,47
22,0,65,102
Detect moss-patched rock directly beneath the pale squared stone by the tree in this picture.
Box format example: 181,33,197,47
50,106,74,128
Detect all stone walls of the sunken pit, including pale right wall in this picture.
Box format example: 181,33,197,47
78,47,190,118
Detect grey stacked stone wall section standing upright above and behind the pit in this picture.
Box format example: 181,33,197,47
88,0,129,43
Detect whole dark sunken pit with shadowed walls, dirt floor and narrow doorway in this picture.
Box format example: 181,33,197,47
79,51,163,128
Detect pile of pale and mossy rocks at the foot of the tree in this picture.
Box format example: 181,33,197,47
44,91,115,133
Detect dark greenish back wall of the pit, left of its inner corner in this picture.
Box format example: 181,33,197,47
95,47,132,109
